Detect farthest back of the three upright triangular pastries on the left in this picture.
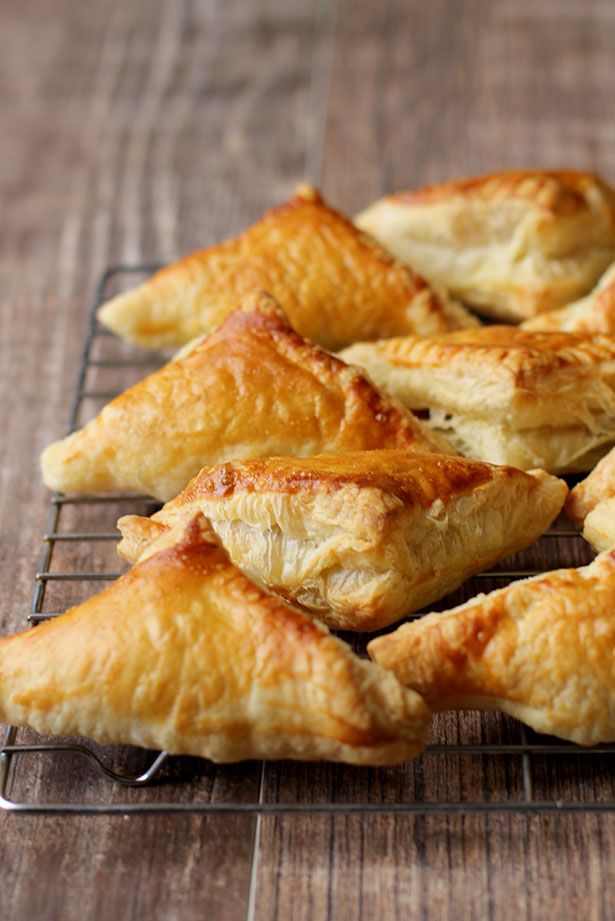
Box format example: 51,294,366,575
98,186,476,349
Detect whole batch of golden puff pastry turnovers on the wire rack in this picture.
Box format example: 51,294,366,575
0,171,615,764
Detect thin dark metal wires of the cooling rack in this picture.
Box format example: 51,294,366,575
0,266,615,816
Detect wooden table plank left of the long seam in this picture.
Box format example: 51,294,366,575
0,0,318,921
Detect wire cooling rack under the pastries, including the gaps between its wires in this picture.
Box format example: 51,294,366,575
0,265,615,816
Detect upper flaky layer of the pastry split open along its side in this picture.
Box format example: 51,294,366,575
340,326,615,427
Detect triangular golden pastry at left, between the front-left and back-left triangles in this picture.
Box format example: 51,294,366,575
41,294,446,501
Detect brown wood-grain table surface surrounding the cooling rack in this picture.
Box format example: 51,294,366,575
0,0,615,921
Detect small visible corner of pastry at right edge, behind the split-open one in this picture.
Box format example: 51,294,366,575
521,262,615,336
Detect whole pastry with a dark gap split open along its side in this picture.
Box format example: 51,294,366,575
340,326,615,473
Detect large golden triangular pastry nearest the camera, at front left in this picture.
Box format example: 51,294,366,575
0,518,430,764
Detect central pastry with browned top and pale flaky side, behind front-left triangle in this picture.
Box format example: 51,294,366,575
118,450,567,630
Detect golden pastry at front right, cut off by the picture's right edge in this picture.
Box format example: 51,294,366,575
368,552,615,745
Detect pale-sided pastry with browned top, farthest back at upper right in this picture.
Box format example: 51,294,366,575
356,170,615,321
